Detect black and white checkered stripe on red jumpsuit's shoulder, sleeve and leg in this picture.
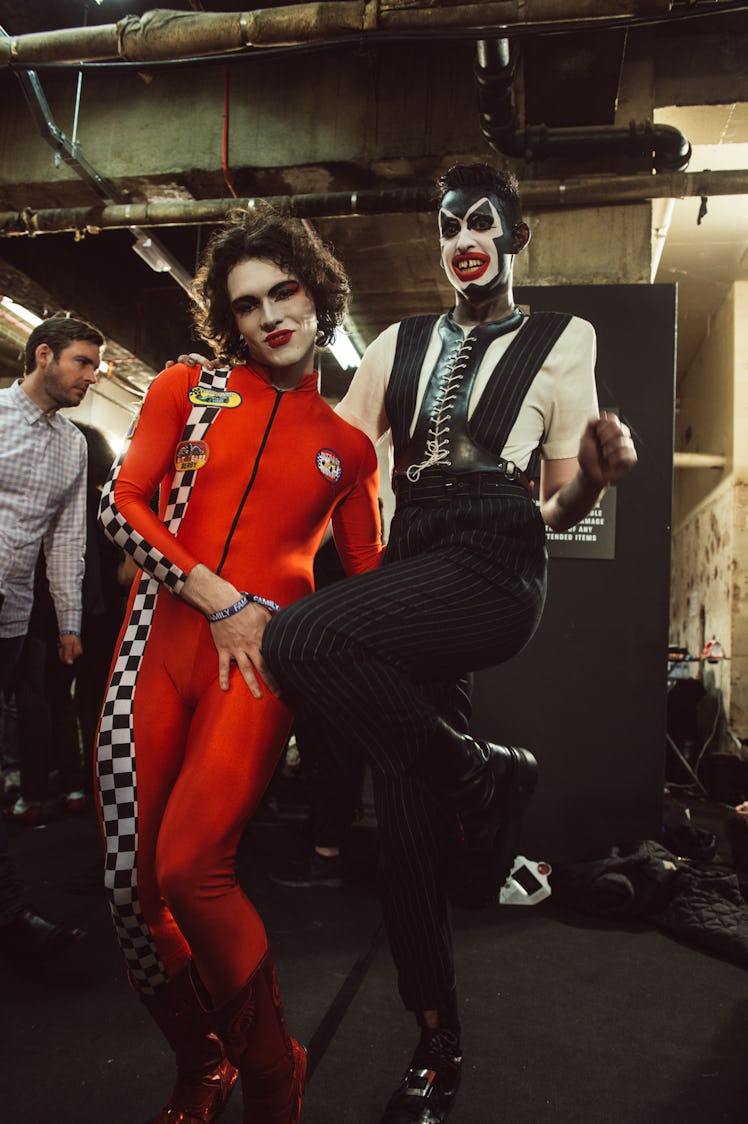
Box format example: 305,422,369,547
97,369,229,994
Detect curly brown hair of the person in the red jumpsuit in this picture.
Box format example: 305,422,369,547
192,201,351,360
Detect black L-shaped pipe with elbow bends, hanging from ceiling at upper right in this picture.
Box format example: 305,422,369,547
475,38,691,172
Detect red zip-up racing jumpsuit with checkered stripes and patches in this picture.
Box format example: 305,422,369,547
97,365,382,995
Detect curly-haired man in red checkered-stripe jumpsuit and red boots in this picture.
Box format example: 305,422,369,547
97,209,382,1124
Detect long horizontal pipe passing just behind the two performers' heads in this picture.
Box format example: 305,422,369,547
0,169,748,238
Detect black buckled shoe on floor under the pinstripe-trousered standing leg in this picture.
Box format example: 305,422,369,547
379,1027,462,1124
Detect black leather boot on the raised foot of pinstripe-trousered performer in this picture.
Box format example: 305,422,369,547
422,718,538,908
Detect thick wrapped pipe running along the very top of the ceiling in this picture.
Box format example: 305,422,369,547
0,0,670,66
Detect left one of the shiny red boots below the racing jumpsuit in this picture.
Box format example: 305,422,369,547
138,967,238,1124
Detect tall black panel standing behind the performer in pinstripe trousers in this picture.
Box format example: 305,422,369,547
472,285,676,861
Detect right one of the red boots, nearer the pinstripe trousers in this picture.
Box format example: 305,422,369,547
206,952,306,1124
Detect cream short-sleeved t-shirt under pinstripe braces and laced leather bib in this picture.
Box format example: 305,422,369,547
337,316,598,469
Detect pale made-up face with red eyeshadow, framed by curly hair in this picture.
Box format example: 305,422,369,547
226,257,317,388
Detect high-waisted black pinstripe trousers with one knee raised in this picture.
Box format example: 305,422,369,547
263,487,546,1012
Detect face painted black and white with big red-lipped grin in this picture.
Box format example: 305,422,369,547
439,189,516,299
